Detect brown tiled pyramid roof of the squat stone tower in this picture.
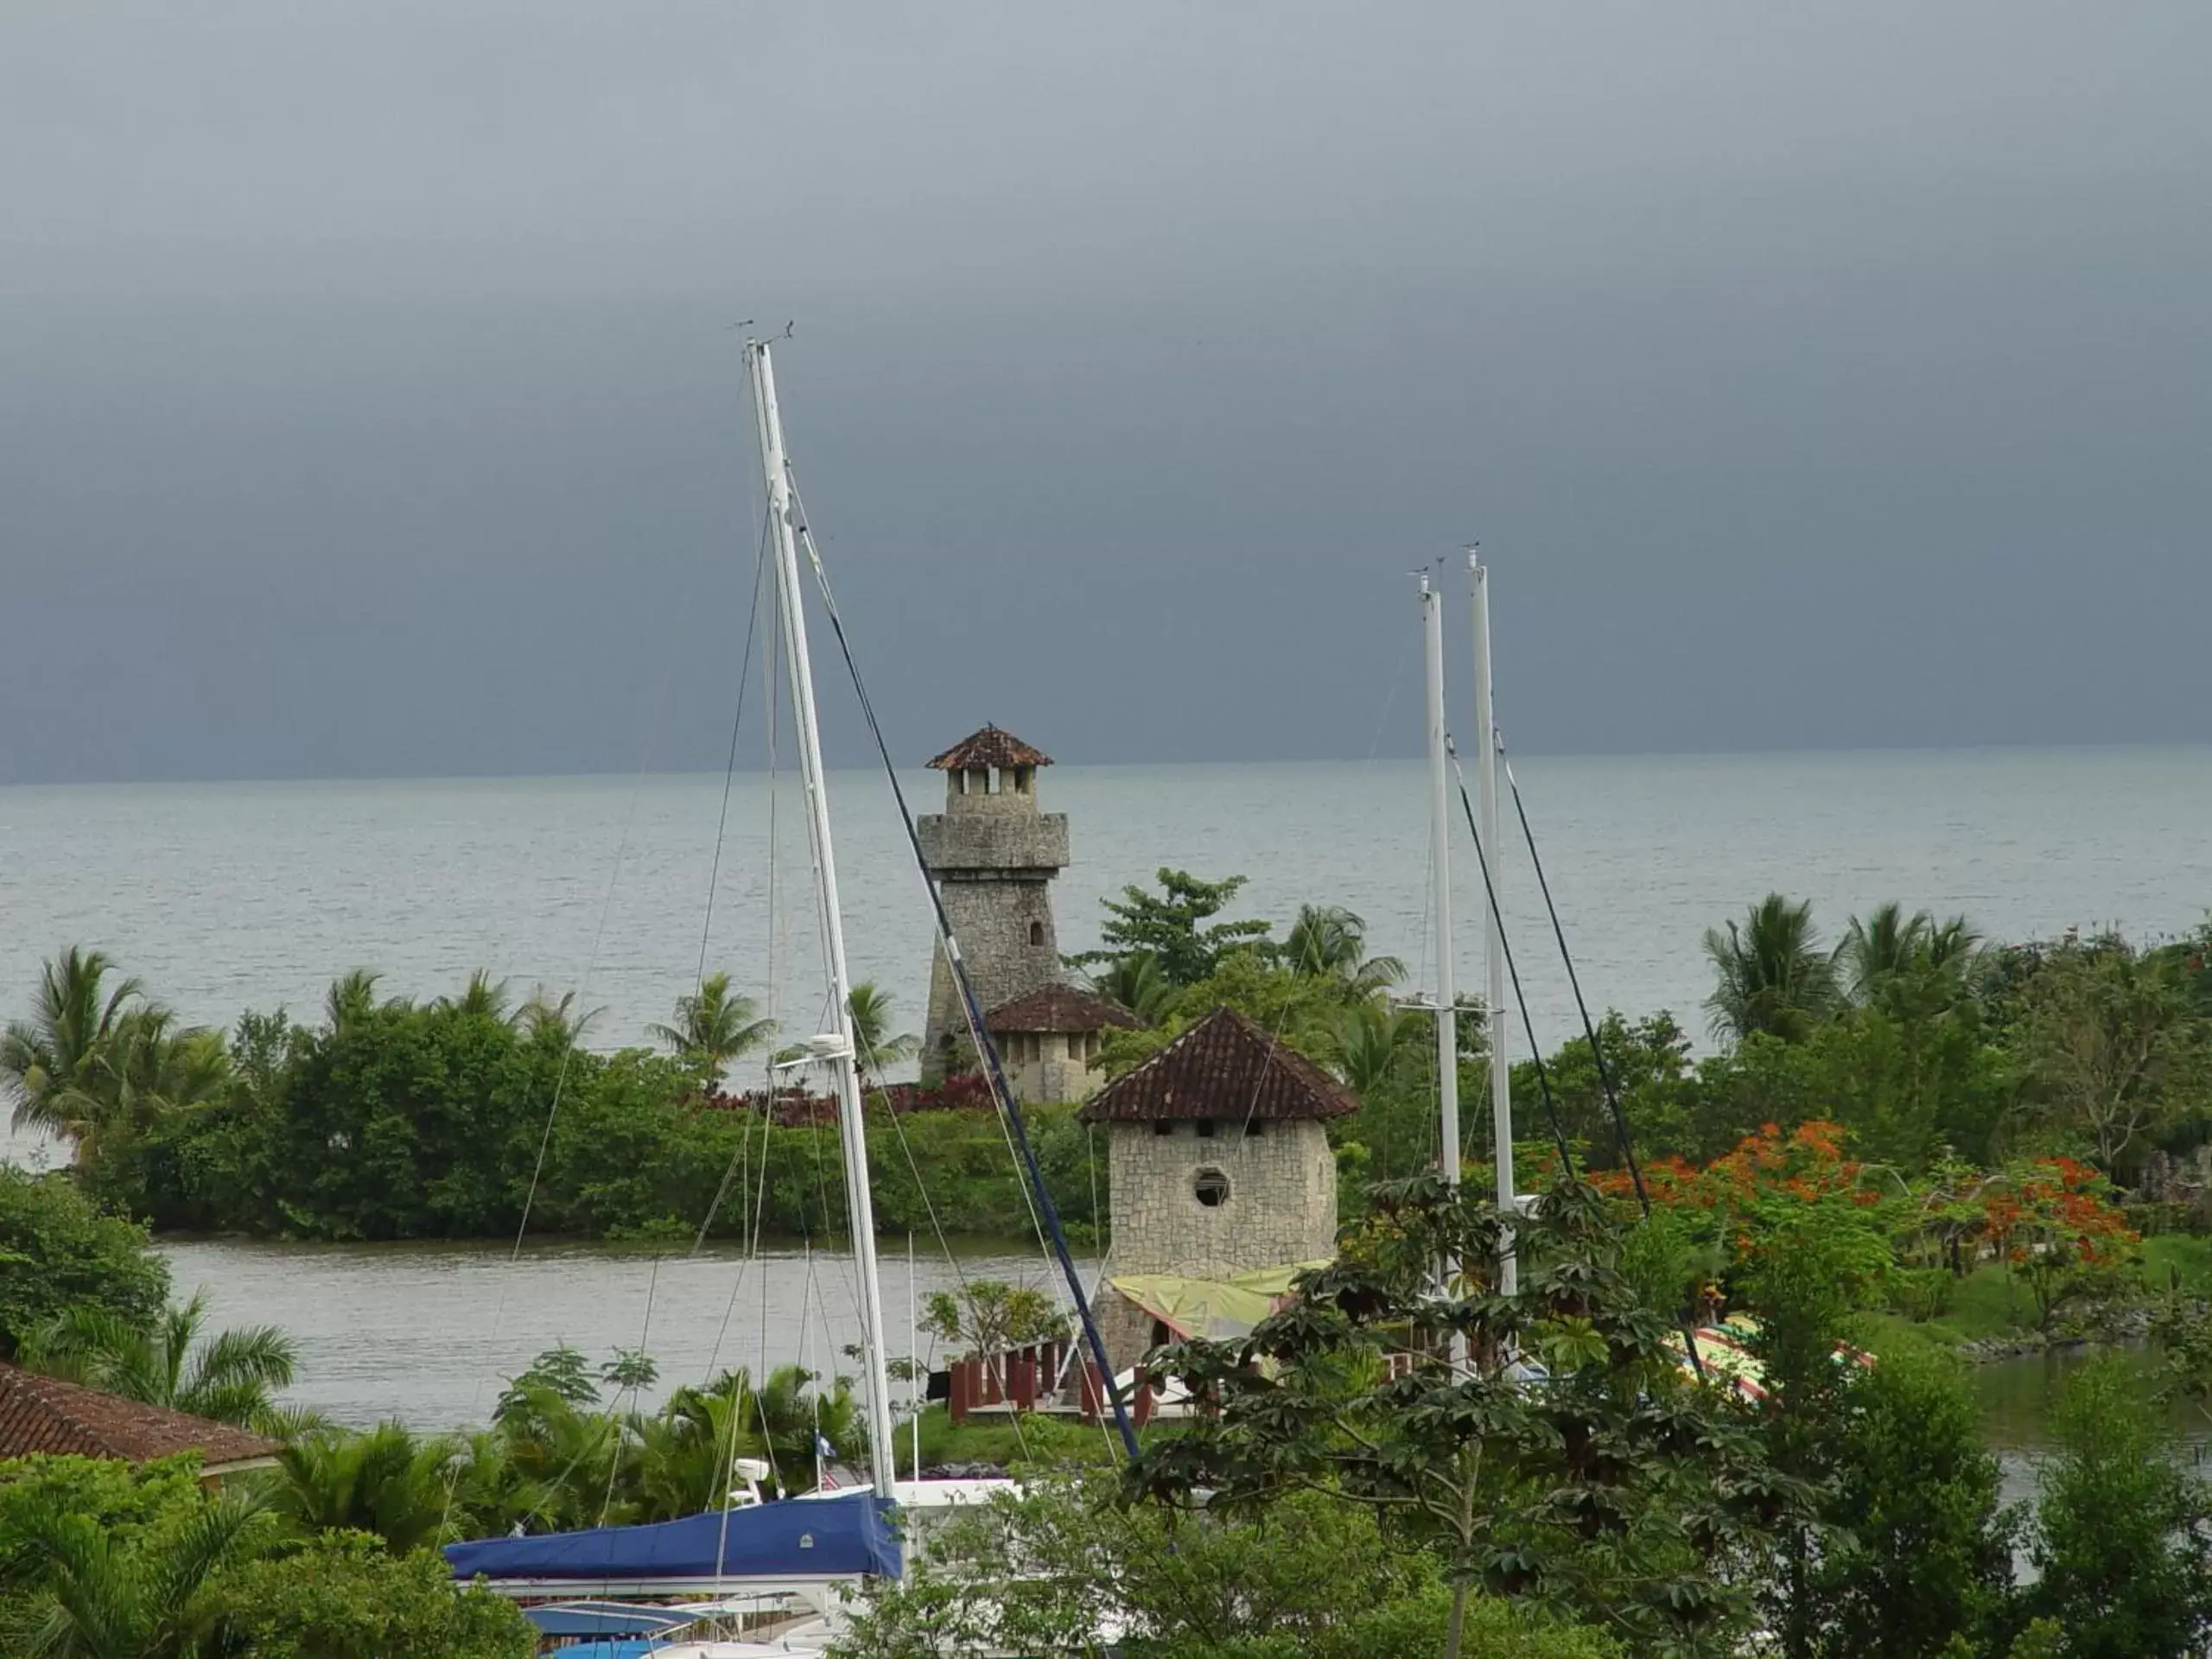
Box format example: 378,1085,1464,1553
1077,1008,1360,1123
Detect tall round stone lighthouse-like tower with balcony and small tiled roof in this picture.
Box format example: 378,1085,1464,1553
916,726,1068,1082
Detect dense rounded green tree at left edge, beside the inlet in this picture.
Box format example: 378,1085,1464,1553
0,1164,168,1360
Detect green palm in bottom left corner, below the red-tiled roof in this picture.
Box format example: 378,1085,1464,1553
9,1493,270,1659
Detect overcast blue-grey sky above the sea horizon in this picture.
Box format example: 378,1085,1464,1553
0,0,2212,781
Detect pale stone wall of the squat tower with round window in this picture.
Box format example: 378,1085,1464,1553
1109,1122,1336,1279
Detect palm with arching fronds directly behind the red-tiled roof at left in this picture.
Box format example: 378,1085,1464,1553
24,1294,299,1433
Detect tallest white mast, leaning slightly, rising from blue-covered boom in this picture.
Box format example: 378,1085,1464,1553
746,340,893,1497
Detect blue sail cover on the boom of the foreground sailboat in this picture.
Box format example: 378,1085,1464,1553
445,1491,898,1584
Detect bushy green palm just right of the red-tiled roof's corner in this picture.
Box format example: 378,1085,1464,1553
268,1422,462,1555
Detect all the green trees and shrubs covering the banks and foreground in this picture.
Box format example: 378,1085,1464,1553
13,885,2212,1659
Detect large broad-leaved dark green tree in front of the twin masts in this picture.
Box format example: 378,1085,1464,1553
1128,1174,1809,1655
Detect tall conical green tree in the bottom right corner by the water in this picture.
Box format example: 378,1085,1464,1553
2026,1358,2212,1659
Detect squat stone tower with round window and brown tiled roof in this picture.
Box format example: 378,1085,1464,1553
1077,1008,1358,1282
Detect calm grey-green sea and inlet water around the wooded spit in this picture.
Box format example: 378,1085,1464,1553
0,747,2212,1422
